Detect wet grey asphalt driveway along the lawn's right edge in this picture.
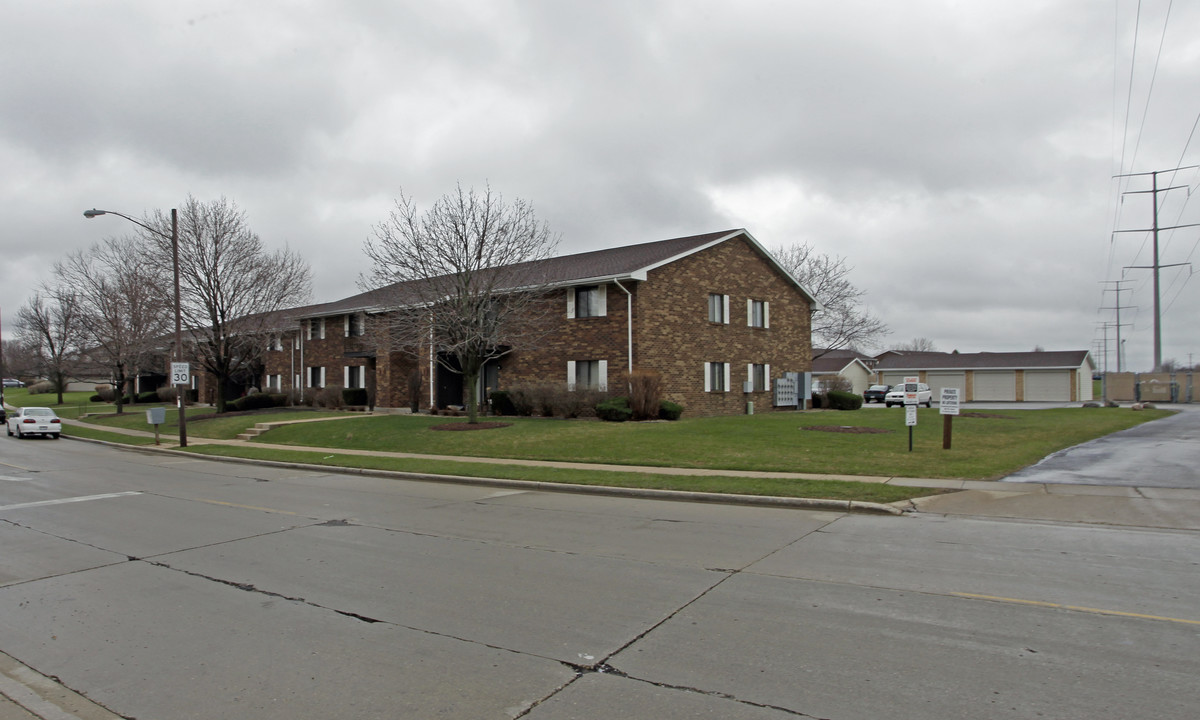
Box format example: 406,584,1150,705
1004,404,1200,490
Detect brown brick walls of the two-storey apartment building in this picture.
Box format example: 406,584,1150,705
265,239,812,415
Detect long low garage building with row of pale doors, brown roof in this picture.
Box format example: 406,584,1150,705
875,350,1096,402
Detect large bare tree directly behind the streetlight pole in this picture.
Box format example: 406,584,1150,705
145,196,312,413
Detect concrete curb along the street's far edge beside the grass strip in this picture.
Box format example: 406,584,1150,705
62,436,908,515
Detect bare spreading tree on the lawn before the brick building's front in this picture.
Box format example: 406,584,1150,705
360,185,557,422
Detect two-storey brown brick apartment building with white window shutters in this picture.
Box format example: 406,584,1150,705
248,229,817,415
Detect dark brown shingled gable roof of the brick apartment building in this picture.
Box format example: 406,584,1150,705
296,229,821,319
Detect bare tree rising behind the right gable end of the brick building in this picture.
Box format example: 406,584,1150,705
773,242,888,359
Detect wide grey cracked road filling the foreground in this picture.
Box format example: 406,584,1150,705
0,438,1200,720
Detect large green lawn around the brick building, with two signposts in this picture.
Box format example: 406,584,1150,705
243,408,1170,479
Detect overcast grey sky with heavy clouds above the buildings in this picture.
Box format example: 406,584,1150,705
0,0,1200,370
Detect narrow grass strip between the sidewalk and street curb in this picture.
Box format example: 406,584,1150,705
180,445,926,503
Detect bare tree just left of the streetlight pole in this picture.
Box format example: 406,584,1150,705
54,238,173,414
